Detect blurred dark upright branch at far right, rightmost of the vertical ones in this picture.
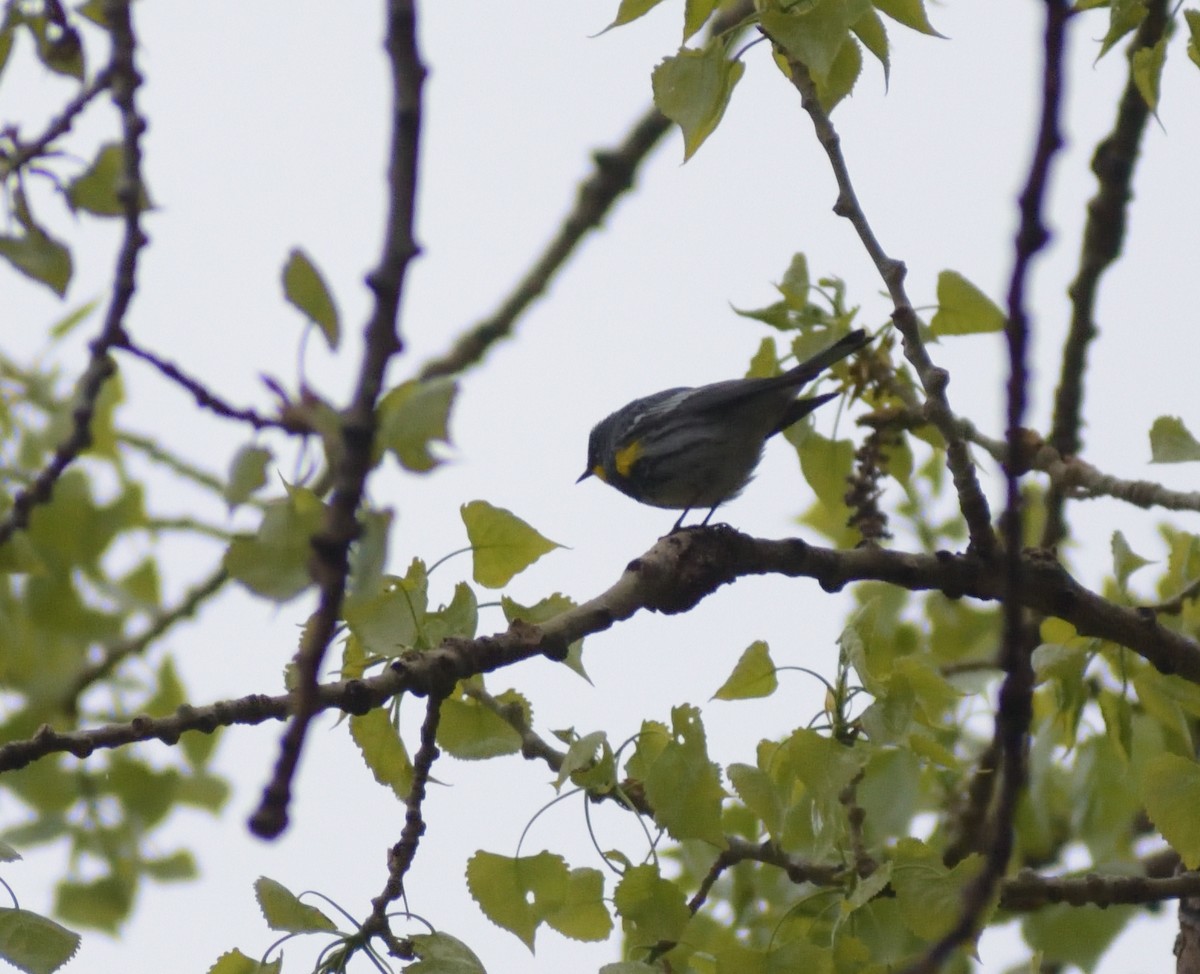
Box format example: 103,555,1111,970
1042,0,1168,548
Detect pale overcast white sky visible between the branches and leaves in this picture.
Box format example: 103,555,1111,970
0,0,1200,974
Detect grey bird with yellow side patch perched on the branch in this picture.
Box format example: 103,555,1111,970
576,329,870,530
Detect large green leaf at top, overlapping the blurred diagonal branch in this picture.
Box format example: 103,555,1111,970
650,38,745,162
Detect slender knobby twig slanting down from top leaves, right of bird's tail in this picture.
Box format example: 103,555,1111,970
775,55,996,558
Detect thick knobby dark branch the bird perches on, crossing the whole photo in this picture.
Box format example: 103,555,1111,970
9,525,1200,772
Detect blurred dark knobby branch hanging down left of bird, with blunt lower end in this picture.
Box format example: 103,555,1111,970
250,0,426,838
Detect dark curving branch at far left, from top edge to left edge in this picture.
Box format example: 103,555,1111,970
0,0,146,545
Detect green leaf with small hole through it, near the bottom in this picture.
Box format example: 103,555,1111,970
467,850,570,951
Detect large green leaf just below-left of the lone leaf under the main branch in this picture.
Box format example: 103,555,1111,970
638,705,726,848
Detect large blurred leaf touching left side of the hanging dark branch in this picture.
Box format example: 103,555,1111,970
223,486,325,602
